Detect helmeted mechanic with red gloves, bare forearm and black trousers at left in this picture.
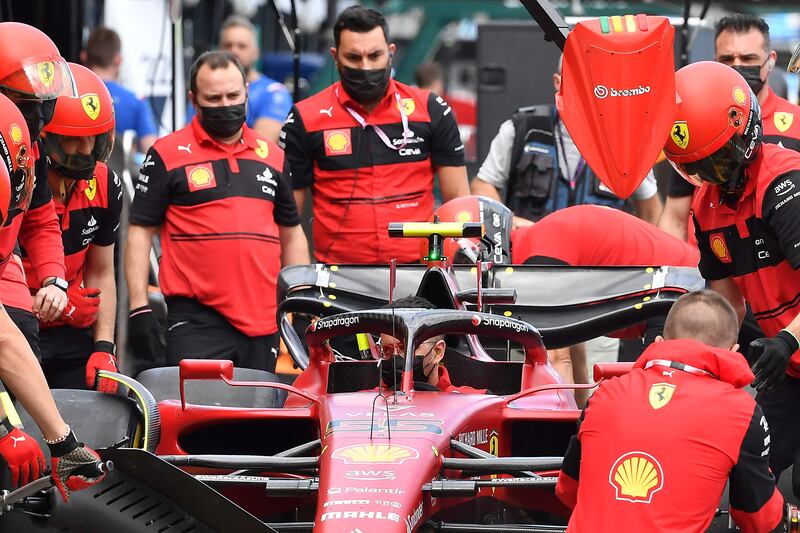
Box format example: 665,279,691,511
23,63,122,393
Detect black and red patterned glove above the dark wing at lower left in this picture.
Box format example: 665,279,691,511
47,431,106,502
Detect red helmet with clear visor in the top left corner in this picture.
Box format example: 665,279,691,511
0,22,75,138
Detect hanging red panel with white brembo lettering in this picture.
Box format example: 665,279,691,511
556,15,677,198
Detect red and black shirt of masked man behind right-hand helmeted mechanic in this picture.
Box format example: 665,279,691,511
668,87,800,198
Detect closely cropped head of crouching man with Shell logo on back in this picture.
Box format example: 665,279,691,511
664,289,739,348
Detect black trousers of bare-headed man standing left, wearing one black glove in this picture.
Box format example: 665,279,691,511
167,297,280,372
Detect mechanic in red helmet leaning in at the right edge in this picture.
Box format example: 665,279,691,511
664,62,800,476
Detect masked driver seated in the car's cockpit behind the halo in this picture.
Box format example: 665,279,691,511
380,296,486,394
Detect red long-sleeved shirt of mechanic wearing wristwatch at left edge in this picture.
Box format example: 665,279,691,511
0,142,66,311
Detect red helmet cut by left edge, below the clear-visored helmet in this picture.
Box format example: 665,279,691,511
0,94,34,213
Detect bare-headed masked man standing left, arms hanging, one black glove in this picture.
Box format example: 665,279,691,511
125,51,308,371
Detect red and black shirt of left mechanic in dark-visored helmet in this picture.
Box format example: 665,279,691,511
22,163,122,296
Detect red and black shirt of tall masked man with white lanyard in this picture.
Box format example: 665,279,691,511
281,80,464,263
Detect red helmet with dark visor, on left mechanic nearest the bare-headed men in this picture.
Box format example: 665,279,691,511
44,63,114,179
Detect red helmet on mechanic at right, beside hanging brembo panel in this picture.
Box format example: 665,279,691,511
664,61,762,190
